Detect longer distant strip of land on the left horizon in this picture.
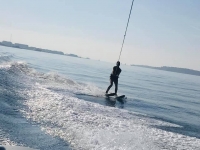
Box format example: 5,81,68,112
0,41,89,59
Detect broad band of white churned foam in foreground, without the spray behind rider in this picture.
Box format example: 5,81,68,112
20,77,200,150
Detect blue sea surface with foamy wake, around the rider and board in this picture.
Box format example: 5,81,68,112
0,46,200,150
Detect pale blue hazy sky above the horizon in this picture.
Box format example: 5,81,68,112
0,0,200,70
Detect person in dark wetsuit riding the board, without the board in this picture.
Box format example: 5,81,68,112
106,61,122,95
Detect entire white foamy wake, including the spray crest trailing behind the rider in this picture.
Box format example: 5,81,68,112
0,54,200,150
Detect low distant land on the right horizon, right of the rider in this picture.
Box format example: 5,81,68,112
131,65,200,76
